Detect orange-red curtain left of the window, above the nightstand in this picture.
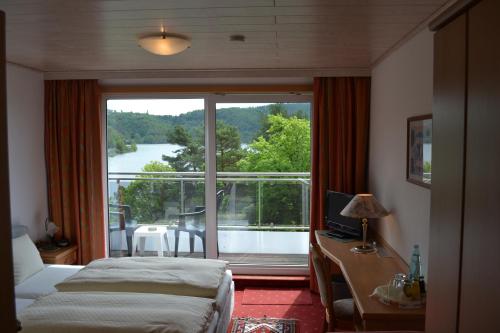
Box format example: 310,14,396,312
45,80,105,264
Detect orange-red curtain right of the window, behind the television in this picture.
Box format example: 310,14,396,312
309,77,370,291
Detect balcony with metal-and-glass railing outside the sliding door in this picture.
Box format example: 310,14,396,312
108,172,310,266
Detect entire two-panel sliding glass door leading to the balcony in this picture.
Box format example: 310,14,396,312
105,95,311,271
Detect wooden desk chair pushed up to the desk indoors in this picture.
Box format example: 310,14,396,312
309,244,354,331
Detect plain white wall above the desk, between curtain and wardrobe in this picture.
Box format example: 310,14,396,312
369,30,433,273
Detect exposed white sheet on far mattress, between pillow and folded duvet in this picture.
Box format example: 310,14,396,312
15,265,83,299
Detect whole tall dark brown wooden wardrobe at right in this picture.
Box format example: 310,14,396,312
426,0,500,333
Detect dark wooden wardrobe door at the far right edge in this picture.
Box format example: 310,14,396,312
459,0,500,333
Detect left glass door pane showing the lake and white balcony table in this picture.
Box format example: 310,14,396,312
106,98,206,257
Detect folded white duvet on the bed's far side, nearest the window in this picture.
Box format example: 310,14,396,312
55,257,227,298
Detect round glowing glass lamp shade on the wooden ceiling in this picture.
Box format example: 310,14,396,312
139,32,191,55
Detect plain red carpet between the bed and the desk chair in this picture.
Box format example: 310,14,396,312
229,288,325,333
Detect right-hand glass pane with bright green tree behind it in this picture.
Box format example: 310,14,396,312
216,103,311,265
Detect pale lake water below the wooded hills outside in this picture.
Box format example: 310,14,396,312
108,143,181,172
